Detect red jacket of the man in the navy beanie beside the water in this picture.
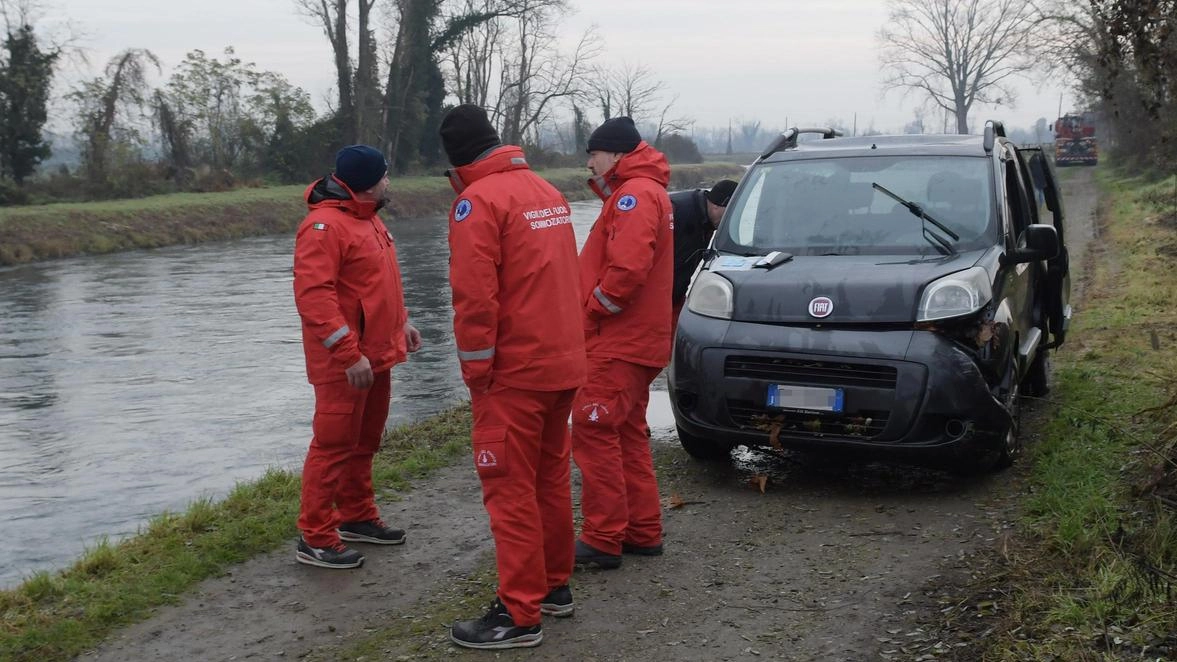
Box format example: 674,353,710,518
294,177,408,384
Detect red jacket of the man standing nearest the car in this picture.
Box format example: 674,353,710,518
580,141,674,368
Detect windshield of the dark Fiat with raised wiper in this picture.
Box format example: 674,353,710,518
716,157,996,256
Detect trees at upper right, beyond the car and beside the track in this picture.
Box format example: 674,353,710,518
879,0,1177,170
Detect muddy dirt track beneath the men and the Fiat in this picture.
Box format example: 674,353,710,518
80,170,1095,662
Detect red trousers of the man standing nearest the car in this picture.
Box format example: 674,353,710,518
572,355,663,554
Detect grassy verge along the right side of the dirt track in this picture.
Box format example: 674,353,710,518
978,171,1177,661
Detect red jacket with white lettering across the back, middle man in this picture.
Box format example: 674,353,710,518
450,145,586,391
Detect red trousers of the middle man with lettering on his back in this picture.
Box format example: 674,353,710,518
471,388,572,625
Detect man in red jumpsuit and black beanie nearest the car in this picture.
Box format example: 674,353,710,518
572,117,674,569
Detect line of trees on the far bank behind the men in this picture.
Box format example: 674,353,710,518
0,0,701,204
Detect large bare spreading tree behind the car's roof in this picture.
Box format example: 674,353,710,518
878,0,1036,133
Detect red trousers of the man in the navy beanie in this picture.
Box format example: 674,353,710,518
298,370,392,547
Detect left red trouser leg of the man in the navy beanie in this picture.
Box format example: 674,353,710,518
298,380,367,547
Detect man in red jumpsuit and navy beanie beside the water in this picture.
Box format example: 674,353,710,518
294,145,421,568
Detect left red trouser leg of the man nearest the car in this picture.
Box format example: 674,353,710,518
572,356,644,554
